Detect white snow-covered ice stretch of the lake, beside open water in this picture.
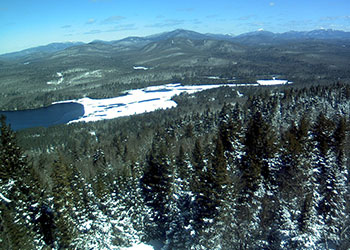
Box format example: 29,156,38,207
56,80,290,123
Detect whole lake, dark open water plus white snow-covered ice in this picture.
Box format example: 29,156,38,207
0,79,288,130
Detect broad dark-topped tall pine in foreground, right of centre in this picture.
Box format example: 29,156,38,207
236,112,277,249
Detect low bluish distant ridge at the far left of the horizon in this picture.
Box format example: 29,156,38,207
0,42,84,59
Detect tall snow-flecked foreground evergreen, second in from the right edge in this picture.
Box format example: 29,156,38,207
300,113,345,248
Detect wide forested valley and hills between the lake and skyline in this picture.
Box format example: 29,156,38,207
0,30,350,110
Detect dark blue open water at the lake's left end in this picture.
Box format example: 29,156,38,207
0,102,84,130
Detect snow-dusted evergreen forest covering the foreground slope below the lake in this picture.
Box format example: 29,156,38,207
0,83,350,250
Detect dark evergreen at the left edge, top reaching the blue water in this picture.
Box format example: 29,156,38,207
0,116,44,249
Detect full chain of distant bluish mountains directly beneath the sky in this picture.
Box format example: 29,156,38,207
0,29,350,61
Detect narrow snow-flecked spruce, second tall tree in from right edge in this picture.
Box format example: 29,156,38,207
305,112,336,246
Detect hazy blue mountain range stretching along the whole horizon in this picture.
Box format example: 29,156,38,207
0,29,350,59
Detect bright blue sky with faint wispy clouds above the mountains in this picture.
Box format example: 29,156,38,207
0,0,350,54
